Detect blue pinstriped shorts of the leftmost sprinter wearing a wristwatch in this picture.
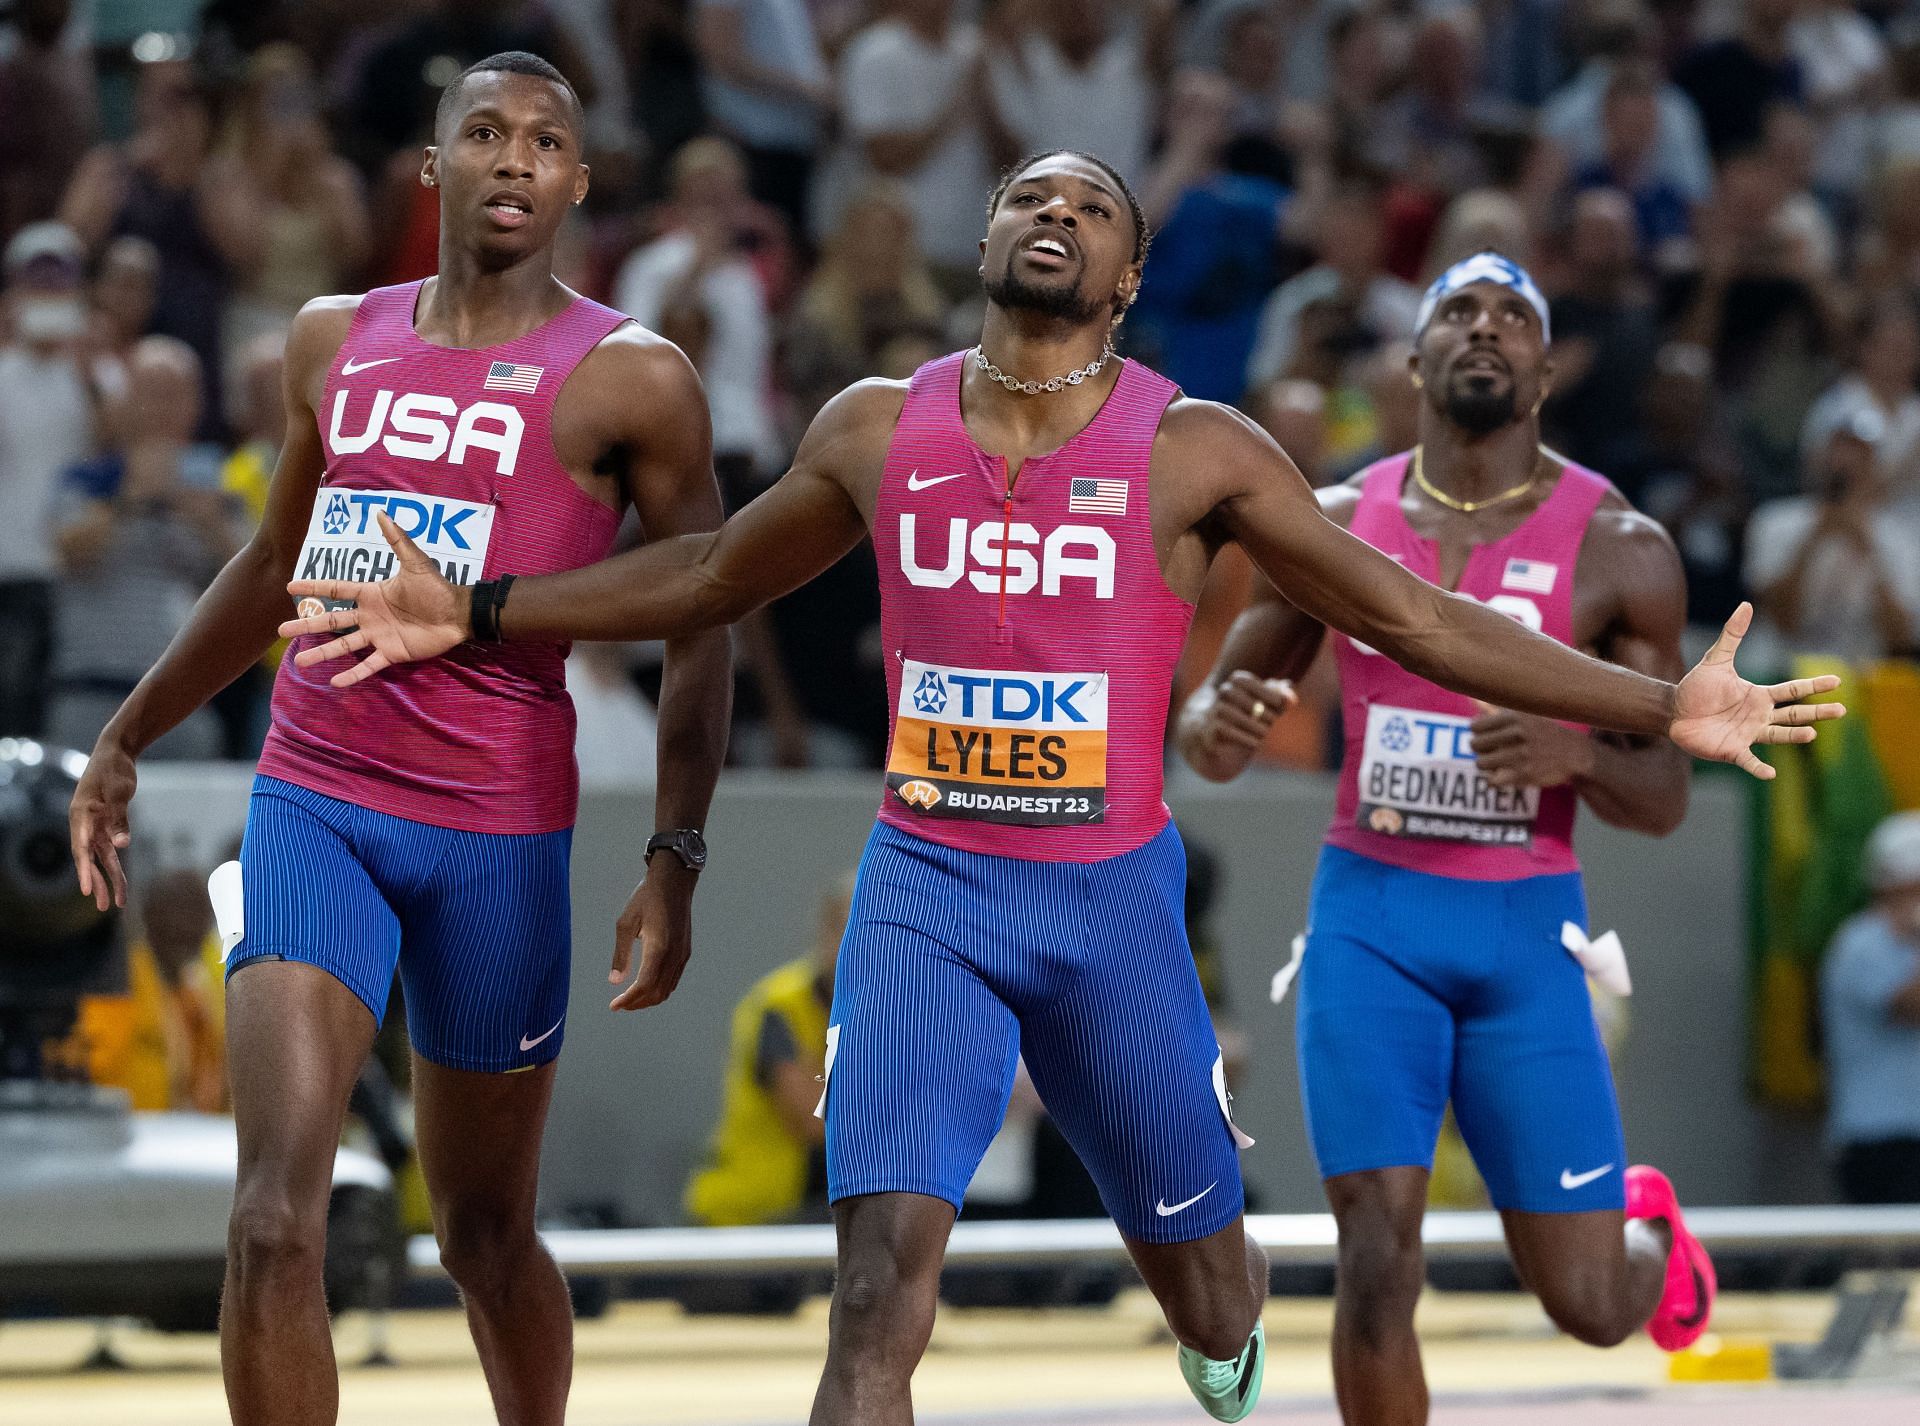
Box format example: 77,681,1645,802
227,777,572,1073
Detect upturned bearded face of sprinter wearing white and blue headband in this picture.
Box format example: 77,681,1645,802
1413,282,1553,436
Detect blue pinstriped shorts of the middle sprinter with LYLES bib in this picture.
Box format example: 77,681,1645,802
826,823,1244,1244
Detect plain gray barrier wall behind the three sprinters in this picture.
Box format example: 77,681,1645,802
136,768,1826,1223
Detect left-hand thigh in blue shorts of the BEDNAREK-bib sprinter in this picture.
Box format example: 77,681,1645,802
1296,848,1453,1178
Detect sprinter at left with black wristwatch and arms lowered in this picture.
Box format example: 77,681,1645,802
73,54,730,1426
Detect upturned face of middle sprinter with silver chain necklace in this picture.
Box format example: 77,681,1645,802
979,154,1140,322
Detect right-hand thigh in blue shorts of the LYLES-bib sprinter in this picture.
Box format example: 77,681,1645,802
1020,825,1244,1244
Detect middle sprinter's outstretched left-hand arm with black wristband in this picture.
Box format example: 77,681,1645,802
280,382,887,687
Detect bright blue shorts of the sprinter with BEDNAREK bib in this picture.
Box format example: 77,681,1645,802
1298,846,1626,1213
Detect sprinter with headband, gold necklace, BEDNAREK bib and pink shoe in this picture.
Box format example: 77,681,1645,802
1179,253,1715,1426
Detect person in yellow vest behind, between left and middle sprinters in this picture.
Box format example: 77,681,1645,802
685,875,852,1228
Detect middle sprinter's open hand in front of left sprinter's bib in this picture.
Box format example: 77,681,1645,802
280,511,470,689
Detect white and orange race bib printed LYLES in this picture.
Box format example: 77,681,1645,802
887,658,1106,827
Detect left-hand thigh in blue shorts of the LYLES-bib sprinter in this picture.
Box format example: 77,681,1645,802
822,825,1020,1209
